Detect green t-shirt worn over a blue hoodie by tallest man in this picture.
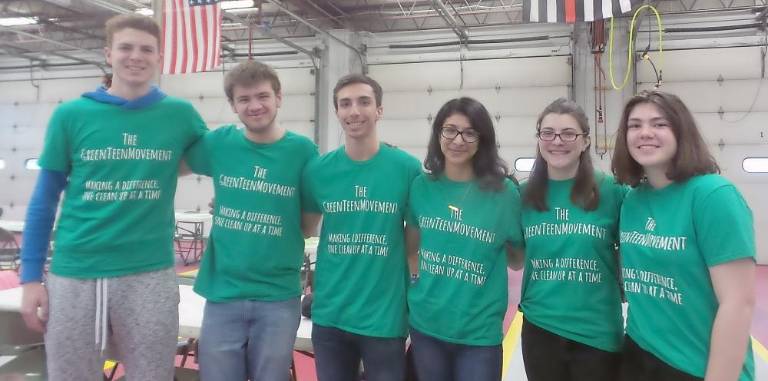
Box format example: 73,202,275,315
39,97,206,279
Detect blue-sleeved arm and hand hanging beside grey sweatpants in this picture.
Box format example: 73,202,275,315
21,169,67,332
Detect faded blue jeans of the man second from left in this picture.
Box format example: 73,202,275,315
198,297,301,381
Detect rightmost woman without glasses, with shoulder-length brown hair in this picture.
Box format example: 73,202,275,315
611,91,755,381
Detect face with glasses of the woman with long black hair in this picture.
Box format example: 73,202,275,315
440,113,480,167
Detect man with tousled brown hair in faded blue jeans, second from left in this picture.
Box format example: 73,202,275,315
186,61,317,381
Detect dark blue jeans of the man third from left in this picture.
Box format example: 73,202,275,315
312,324,405,381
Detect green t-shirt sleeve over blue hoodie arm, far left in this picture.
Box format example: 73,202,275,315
38,103,72,173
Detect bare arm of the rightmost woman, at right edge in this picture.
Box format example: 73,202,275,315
704,258,755,381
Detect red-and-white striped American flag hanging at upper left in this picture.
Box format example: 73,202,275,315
163,0,221,74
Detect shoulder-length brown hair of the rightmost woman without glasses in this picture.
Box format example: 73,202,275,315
611,91,720,187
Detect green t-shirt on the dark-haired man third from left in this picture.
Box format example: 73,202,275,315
302,144,421,337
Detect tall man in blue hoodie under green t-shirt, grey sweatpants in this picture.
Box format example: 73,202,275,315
21,15,205,381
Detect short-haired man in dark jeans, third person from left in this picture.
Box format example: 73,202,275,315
302,74,421,381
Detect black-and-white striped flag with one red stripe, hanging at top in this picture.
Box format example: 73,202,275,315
523,0,642,24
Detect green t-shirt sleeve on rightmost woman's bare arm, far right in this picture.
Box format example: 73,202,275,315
693,185,755,267
